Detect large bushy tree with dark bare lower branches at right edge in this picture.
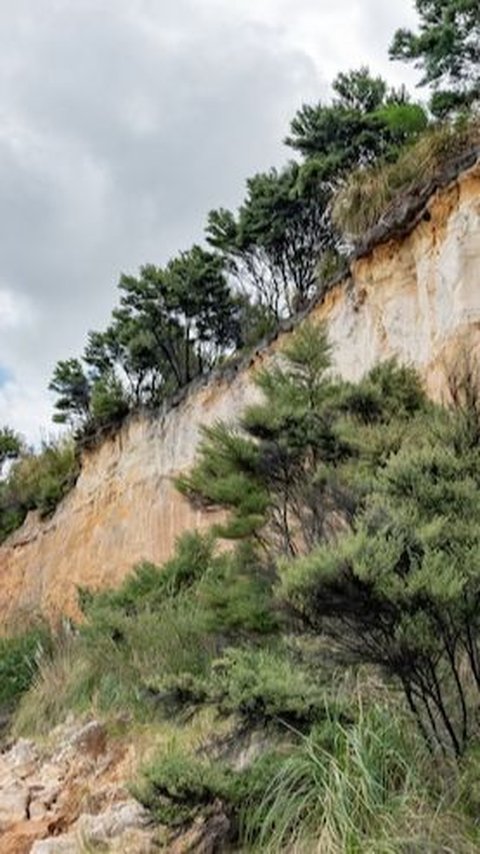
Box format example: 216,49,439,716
280,360,480,755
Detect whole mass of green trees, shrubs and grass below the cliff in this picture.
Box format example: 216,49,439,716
5,323,480,852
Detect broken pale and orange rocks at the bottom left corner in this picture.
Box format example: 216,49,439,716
0,721,158,854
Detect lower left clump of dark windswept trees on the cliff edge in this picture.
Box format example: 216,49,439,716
50,246,242,428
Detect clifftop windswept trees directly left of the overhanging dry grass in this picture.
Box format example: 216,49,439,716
206,68,427,320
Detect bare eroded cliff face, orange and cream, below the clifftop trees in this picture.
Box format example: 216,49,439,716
0,164,480,621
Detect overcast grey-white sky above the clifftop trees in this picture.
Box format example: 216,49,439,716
0,0,416,441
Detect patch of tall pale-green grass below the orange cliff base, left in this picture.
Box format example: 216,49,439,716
14,597,213,735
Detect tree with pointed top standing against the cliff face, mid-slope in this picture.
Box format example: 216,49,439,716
178,324,356,559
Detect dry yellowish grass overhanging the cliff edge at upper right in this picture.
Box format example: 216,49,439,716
333,119,480,242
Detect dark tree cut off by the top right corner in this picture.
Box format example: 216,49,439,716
390,0,480,115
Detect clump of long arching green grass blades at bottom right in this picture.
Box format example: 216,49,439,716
243,707,478,854
